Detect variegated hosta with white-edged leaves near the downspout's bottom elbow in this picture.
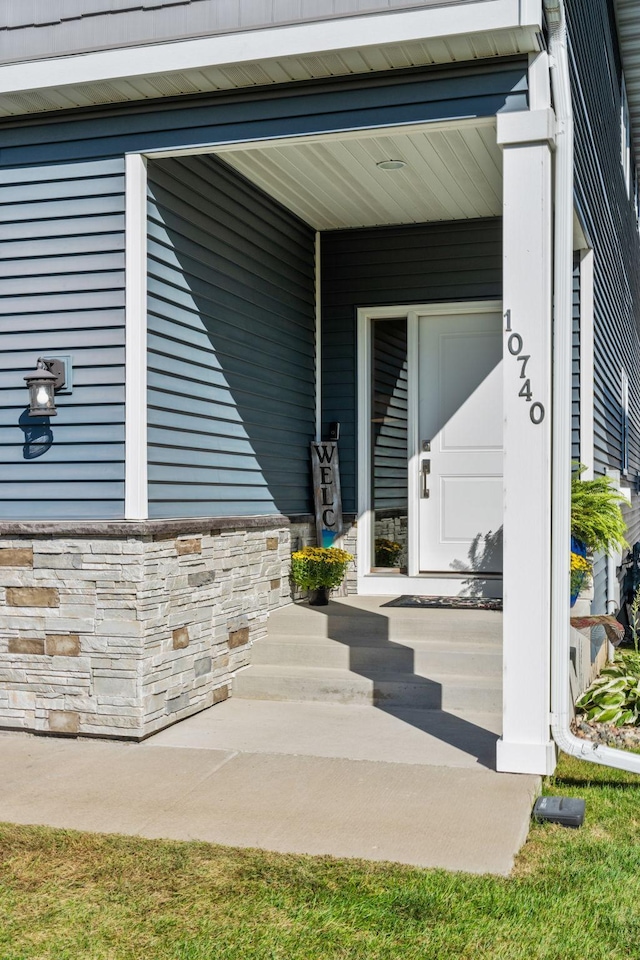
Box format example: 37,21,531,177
576,655,640,727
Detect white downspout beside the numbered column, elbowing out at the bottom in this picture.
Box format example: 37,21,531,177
544,0,640,773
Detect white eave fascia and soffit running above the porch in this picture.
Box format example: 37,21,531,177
0,0,542,117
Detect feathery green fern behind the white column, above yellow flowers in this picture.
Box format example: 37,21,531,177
571,464,629,554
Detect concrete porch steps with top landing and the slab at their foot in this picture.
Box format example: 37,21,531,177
160,596,502,770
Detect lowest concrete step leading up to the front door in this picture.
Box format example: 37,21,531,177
232,664,502,713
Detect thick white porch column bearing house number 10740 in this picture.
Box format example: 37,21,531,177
497,109,555,774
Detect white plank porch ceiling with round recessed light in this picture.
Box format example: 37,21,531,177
220,119,502,230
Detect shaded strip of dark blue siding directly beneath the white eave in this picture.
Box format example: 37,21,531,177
0,58,527,165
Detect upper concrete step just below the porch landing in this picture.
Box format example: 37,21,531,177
251,634,502,680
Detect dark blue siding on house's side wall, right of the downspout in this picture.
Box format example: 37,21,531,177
566,0,640,613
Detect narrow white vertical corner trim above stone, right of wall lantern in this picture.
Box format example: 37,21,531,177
125,154,149,520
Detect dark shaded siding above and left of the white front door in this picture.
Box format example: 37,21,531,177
321,220,502,512
